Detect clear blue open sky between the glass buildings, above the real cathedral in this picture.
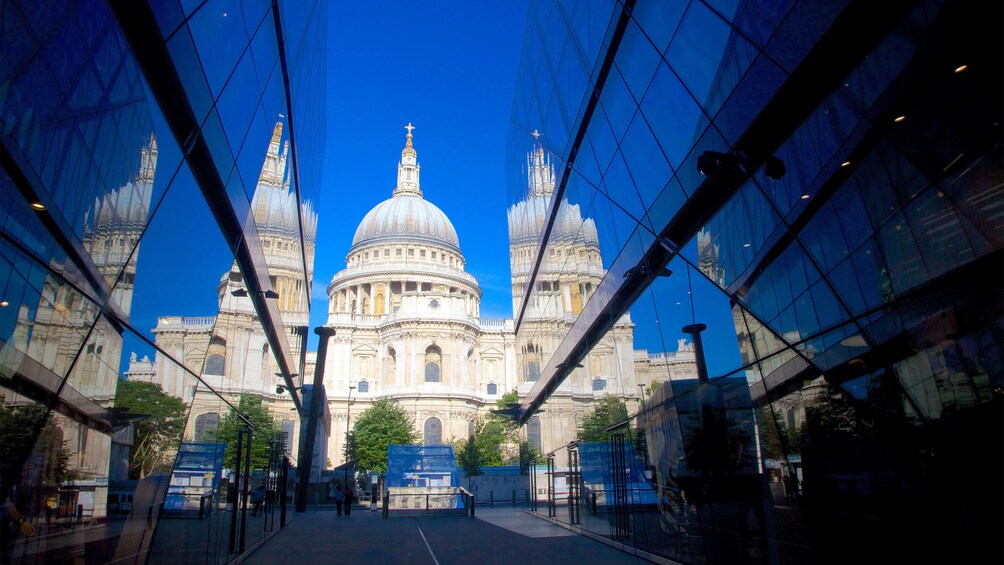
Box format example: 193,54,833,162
311,0,527,345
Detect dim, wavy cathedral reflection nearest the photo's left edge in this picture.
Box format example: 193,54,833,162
0,134,158,516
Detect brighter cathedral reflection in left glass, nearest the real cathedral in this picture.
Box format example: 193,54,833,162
129,122,317,417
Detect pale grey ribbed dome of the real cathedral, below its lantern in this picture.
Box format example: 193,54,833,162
348,195,460,255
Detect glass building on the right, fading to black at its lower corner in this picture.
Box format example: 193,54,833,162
507,0,1004,564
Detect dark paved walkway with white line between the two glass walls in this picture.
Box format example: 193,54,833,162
245,508,647,565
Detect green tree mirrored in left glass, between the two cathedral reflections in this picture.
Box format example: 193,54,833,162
115,380,188,479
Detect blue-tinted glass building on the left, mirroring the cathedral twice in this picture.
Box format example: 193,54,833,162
0,0,326,563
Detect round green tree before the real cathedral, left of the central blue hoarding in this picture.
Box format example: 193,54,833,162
349,398,419,475
